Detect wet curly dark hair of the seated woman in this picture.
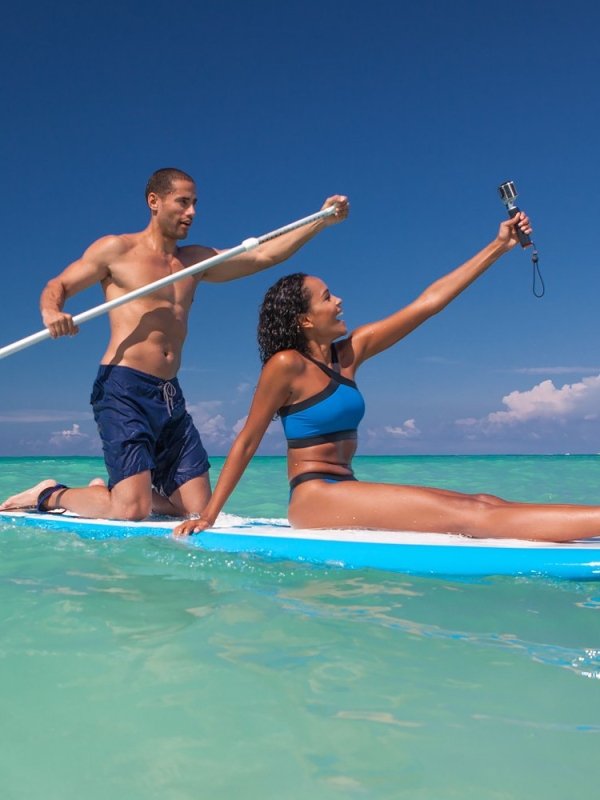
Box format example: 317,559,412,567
257,272,310,366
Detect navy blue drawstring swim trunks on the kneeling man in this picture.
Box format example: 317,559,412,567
90,365,210,497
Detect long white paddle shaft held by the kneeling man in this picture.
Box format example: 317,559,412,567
0,205,336,359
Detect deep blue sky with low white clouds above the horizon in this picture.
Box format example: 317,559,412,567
0,0,600,456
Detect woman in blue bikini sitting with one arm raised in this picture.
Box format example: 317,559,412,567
175,213,600,541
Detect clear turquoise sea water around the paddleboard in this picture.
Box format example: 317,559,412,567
0,456,600,800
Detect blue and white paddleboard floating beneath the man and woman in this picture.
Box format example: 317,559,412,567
0,512,600,580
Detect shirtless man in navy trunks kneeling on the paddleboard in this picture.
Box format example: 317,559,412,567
0,169,349,520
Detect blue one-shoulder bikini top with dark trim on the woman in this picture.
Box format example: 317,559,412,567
279,345,365,447
